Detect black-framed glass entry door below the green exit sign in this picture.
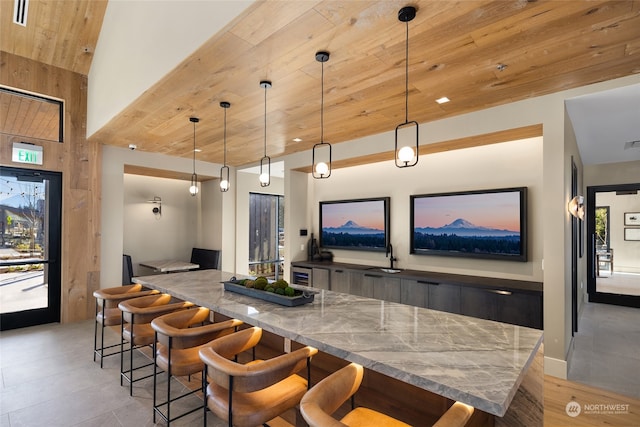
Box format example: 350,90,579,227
0,166,62,330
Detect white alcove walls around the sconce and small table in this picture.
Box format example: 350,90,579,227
100,145,222,288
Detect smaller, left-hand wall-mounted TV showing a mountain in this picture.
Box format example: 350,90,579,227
319,197,390,251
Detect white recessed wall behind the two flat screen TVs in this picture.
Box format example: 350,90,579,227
311,137,543,282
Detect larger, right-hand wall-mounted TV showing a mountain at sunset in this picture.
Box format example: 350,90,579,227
410,187,527,261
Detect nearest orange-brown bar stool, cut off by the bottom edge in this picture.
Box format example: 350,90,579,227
300,363,474,427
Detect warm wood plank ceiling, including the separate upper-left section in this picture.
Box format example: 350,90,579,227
0,0,640,170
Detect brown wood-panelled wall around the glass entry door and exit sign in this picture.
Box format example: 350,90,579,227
0,52,102,323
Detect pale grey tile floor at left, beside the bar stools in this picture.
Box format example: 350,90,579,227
0,321,226,427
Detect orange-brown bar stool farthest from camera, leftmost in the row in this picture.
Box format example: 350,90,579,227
93,285,160,368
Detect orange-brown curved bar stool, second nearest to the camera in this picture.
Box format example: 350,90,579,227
200,327,318,427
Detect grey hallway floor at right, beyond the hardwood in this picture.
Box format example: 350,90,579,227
568,303,640,399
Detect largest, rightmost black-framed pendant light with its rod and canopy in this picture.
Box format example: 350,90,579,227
395,6,418,168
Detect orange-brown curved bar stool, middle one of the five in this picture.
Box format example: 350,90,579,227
151,307,242,426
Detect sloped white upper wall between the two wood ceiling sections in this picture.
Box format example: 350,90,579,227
87,0,252,136
